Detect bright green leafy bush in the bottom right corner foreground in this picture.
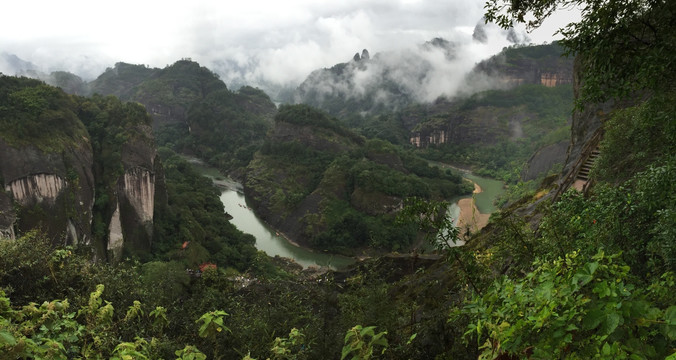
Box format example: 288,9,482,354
465,251,676,359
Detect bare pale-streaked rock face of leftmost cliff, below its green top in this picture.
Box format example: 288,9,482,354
0,139,94,244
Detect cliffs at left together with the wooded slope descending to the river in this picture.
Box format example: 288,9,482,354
0,76,256,270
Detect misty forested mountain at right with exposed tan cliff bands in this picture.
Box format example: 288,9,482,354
394,44,573,186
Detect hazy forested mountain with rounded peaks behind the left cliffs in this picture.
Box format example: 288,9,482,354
89,59,276,171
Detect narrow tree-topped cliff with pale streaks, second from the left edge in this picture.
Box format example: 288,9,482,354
79,96,166,261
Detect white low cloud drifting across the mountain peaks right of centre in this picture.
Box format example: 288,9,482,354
294,24,526,110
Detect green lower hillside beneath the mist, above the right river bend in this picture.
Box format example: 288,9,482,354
410,84,573,205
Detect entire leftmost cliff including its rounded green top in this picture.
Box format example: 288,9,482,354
0,77,95,244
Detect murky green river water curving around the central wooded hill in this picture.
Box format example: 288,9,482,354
185,157,503,269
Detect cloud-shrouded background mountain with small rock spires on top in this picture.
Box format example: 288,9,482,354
294,38,462,118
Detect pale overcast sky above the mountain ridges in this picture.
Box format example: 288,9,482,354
0,0,570,85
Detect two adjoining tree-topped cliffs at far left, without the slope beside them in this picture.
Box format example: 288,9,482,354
0,76,164,261
